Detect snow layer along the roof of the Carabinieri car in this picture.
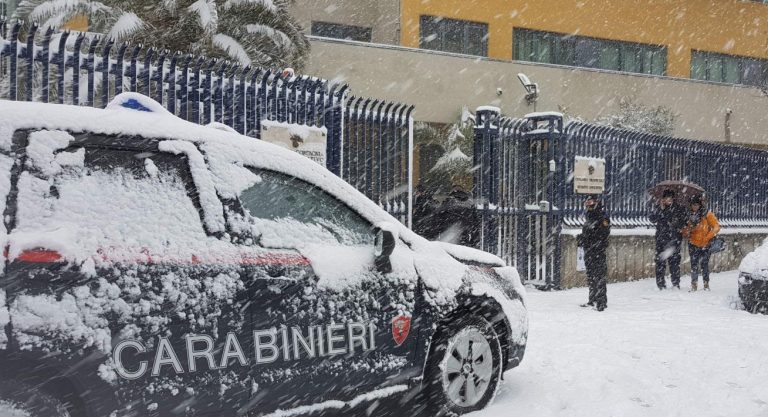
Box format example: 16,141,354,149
0,93,390,231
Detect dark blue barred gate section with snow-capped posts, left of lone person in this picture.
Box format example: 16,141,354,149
474,107,563,288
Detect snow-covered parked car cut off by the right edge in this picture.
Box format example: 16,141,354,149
739,239,768,313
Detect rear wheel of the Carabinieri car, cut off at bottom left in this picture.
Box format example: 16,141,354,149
0,380,70,417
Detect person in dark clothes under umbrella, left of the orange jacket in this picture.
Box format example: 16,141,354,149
649,190,687,290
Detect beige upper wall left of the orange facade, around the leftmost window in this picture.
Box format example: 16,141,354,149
289,0,400,45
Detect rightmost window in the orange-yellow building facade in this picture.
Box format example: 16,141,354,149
691,51,768,85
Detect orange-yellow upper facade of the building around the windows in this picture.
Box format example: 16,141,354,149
400,0,768,78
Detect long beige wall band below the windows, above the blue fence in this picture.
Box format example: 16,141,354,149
307,38,768,146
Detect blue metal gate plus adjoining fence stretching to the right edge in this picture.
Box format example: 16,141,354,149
474,107,768,287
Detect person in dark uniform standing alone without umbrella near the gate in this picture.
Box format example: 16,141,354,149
577,195,611,311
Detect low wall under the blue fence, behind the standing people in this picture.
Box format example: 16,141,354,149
561,234,768,288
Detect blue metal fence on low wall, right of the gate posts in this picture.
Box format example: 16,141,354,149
563,123,768,227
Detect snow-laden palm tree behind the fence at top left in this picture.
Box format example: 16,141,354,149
14,0,309,70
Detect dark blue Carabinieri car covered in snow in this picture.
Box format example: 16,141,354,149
0,94,528,417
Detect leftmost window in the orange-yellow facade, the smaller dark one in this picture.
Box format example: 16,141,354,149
419,16,488,56
